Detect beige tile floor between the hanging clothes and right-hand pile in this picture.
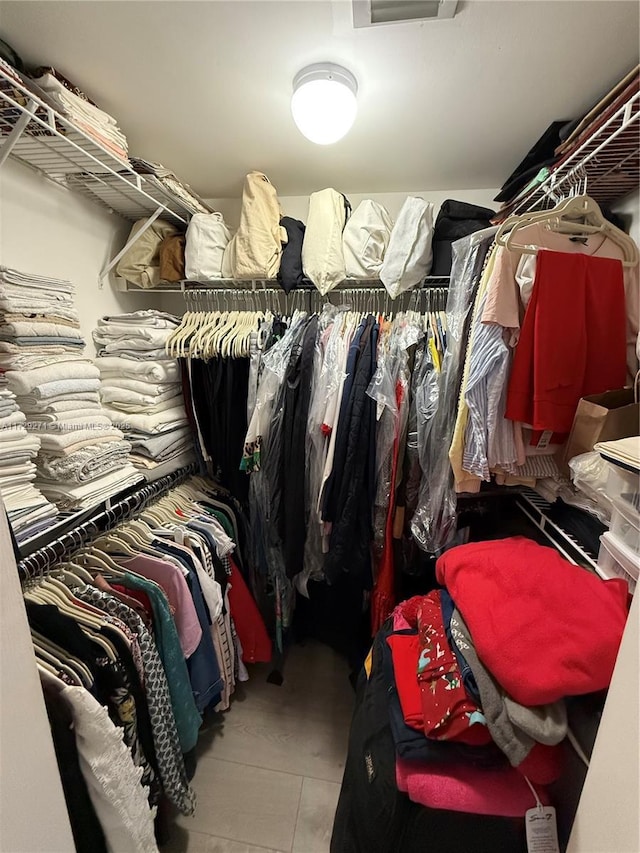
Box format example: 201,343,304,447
161,642,354,853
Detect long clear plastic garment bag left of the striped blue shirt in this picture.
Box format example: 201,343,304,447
411,228,497,554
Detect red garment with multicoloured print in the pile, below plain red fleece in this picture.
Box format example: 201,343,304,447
417,590,491,744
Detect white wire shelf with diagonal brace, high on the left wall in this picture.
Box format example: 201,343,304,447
0,68,199,286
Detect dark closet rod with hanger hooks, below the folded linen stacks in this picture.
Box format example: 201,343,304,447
18,464,196,580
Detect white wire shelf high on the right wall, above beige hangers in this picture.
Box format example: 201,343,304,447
507,85,640,214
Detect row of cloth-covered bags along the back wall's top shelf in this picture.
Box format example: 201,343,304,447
116,172,494,298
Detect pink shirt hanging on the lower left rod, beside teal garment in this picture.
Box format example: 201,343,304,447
121,554,202,658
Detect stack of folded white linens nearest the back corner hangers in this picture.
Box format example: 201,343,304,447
93,311,194,480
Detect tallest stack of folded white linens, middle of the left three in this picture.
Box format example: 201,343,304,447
0,268,140,510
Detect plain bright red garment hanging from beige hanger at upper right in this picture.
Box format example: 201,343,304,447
505,250,627,432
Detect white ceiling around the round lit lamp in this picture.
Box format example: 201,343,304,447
0,0,639,198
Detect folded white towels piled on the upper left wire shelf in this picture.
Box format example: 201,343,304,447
34,68,129,163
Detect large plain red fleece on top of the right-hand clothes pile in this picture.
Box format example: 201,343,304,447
436,536,627,705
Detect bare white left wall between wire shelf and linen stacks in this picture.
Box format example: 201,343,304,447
0,158,158,357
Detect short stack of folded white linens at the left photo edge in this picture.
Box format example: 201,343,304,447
0,377,57,542
